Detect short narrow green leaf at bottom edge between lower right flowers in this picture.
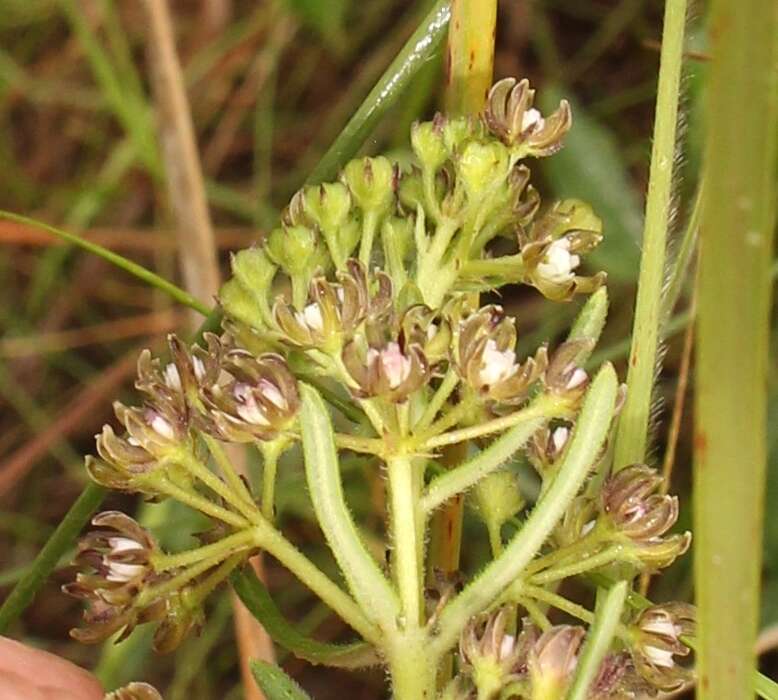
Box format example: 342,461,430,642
567,581,627,700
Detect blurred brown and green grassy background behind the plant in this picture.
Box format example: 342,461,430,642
0,0,778,700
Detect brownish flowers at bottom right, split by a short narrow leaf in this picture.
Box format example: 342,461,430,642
450,604,694,700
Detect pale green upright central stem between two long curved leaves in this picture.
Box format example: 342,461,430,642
386,456,424,628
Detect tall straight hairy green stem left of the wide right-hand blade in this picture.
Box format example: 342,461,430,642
614,0,686,469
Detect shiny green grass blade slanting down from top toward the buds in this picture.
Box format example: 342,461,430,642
307,0,451,185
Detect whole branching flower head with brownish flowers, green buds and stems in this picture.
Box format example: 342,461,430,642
62,79,693,700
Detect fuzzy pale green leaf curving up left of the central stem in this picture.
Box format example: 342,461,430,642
300,385,400,625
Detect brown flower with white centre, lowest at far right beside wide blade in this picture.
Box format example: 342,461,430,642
632,603,695,691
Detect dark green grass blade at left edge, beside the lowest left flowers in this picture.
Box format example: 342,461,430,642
0,484,105,634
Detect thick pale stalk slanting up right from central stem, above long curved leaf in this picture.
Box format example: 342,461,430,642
420,409,548,514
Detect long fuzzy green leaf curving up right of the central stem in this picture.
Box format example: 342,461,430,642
433,365,618,653
